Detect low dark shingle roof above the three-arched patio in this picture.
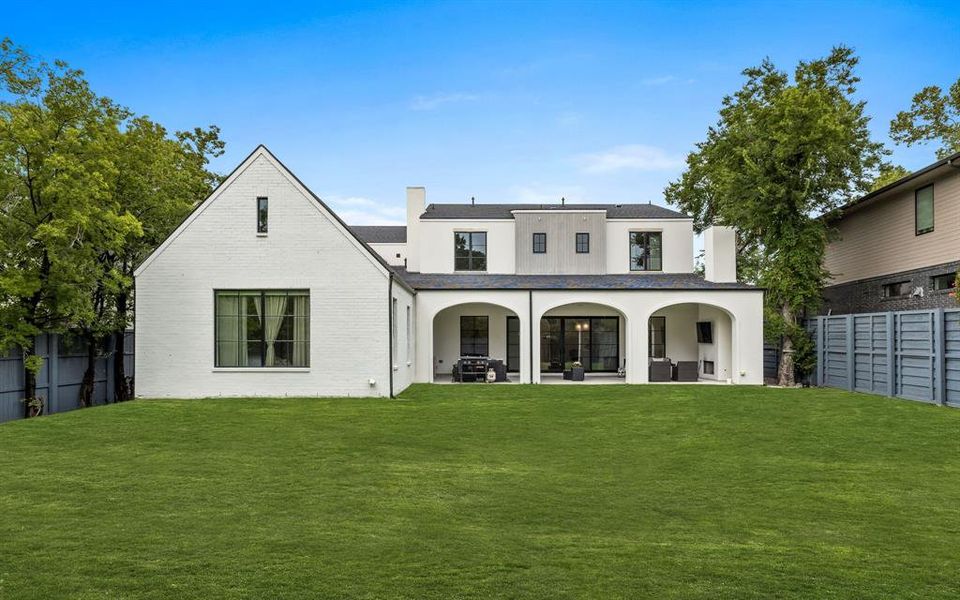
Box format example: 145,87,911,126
395,269,760,290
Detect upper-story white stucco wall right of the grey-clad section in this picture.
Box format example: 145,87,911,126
606,219,693,273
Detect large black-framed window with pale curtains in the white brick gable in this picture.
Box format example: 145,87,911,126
214,290,310,367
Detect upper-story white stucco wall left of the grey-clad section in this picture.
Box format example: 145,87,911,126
416,219,517,273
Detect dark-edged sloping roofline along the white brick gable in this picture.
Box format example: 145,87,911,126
134,144,414,292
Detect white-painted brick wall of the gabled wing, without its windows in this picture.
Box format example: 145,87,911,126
136,148,402,398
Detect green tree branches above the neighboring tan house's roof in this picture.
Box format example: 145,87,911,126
890,78,960,158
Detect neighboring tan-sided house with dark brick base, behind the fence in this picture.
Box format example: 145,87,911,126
821,153,960,314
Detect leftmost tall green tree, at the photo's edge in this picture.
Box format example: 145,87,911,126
0,40,139,413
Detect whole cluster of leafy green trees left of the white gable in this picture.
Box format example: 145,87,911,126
0,40,223,412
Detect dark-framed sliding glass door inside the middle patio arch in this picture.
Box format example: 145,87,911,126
540,317,620,373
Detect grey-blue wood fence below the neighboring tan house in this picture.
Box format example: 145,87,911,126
811,308,960,407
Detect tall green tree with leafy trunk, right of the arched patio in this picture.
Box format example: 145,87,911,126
665,46,885,385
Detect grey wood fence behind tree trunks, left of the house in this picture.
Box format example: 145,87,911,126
0,331,134,423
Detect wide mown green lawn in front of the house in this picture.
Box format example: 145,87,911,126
0,385,960,599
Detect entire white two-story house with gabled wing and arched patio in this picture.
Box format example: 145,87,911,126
136,146,763,397
